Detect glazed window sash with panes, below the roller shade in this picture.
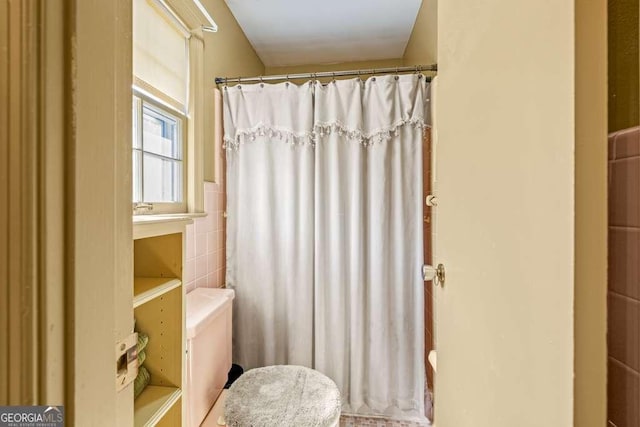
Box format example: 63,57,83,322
133,96,185,212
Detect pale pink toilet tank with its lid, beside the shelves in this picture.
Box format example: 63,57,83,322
185,288,234,427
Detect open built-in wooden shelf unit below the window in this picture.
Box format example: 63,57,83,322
132,227,185,427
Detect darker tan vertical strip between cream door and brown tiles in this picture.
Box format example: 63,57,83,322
574,0,608,427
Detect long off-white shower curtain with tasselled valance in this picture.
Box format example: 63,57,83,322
224,75,430,419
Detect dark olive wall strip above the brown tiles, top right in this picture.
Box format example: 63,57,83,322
608,0,640,132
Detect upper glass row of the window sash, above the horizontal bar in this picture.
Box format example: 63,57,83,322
142,106,182,159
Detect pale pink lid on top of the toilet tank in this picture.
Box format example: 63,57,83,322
186,288,234,339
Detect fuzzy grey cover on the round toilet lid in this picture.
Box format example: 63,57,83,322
224,365,341,427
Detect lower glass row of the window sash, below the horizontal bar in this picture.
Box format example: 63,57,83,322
143,153,182,203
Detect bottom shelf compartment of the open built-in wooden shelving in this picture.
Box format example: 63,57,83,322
133,385,182,427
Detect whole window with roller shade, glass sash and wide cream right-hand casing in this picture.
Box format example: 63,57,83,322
132,0,216,214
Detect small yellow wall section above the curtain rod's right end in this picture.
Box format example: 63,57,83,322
403,0,438,65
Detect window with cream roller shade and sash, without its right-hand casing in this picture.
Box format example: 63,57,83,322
133,0,189,213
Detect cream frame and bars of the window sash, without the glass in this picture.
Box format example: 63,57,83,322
131,91,189,215
